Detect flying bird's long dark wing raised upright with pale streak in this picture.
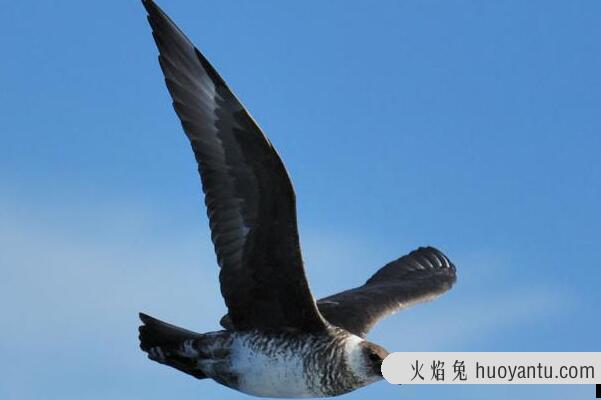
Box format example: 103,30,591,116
143,0,325,331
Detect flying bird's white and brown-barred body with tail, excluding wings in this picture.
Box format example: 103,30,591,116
141,315,387,398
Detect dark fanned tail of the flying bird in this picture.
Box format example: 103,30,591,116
139,313,206,379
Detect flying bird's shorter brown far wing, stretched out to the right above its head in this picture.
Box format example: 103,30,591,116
317,247,456,337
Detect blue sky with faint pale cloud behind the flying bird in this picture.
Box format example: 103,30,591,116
0,0,601,400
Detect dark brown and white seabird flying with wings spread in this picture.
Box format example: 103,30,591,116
139,0,456,398
